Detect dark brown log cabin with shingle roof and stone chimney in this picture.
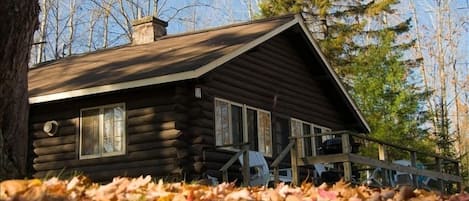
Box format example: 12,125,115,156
28,15,369,181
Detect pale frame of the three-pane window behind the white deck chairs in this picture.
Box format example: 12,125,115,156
213,97,273,157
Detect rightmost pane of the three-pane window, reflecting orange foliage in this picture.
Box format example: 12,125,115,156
258,111,272,156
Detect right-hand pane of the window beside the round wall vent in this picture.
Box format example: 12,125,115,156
103,106,124,153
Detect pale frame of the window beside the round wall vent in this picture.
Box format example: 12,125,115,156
78,103,127,159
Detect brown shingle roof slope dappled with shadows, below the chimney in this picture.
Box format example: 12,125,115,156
29,16,294,97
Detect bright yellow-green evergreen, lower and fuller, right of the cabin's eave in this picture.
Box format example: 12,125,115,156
350,31,431,159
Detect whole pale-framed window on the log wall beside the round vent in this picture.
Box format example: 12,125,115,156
80,104,125,159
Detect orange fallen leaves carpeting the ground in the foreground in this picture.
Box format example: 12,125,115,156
0,176,469,201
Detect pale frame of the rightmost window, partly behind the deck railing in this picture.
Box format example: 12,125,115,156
290,117,332,157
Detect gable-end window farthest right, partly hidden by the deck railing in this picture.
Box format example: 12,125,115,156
291,118,330,157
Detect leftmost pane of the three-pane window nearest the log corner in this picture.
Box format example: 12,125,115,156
215,100,231,145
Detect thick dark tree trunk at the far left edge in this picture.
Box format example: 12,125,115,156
0,0,39,179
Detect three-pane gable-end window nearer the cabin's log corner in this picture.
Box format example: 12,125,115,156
215,98,272,156
